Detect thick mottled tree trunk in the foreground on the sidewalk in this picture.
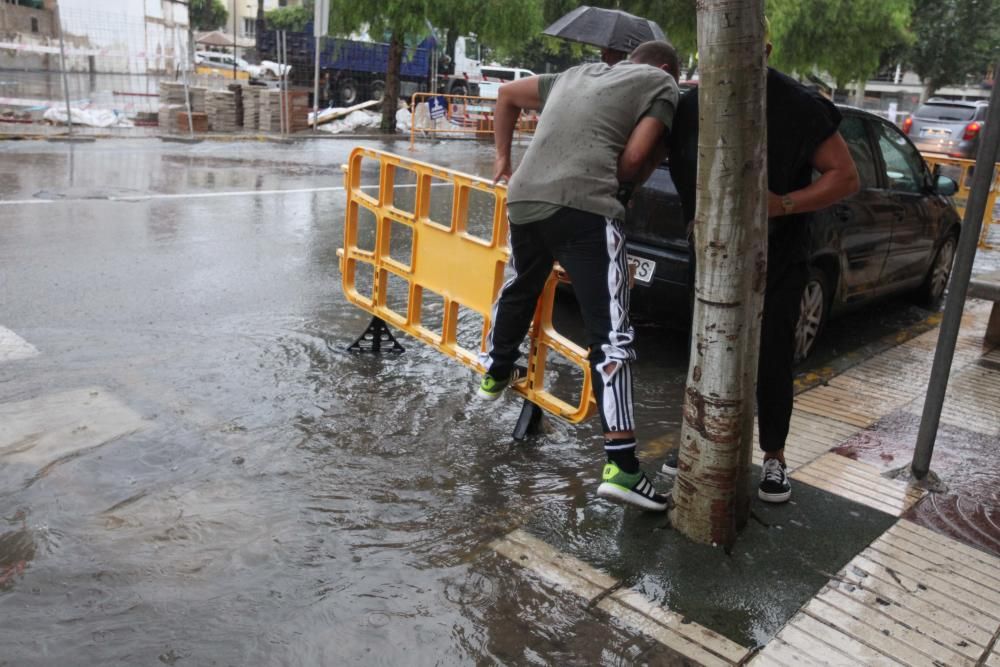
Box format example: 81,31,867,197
671,0,767,547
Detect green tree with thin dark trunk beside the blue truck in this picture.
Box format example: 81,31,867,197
330,0,542,132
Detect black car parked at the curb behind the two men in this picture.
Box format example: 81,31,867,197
625,107,961,360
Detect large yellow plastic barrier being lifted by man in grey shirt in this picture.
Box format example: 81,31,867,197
338,147,595,422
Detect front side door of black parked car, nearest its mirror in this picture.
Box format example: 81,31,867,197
874,120,936,288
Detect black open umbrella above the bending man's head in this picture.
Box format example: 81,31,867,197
542,5,666,53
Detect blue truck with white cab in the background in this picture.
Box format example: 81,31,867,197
257,23,479,107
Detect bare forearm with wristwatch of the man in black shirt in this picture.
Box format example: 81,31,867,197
767,132,861,218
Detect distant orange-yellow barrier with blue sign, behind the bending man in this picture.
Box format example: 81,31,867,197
410,93,538,149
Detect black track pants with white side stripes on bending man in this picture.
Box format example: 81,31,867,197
483,208,635,433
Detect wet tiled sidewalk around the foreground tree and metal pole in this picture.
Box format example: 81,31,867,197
493,300,1000,667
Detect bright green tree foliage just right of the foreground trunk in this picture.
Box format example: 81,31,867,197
767,0,913,87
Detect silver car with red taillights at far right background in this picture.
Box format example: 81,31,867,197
903,97,988,159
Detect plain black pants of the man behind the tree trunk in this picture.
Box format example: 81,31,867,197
757,263,809,452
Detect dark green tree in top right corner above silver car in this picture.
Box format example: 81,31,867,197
906,0,1000,99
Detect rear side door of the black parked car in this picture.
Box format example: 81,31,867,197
828,113,894,302
